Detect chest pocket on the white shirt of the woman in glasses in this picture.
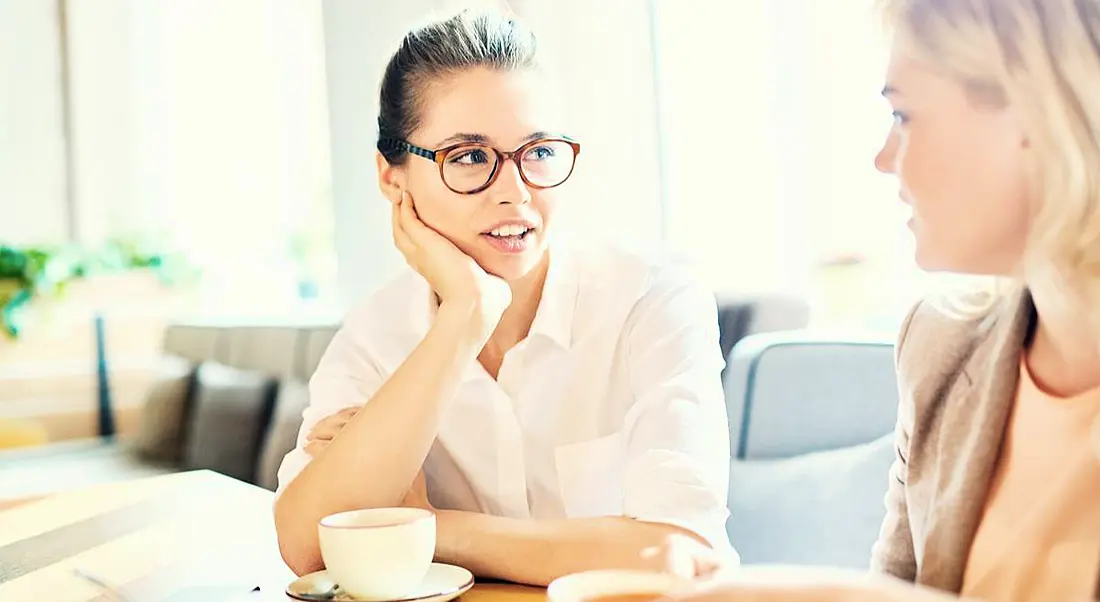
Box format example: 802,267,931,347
554,433,626,518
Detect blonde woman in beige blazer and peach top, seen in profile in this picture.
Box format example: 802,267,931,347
655,0,1100,601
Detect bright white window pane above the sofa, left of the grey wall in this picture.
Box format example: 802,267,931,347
123,0,334,314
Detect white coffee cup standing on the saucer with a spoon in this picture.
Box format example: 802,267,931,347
317,508,436,600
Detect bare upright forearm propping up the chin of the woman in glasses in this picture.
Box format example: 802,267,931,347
275,305,484,574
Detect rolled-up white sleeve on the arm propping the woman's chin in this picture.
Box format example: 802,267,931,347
275,321,384,495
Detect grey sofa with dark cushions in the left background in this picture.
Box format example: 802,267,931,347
0,322,337,500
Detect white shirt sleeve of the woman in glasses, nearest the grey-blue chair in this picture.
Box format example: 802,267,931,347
623,267,736,557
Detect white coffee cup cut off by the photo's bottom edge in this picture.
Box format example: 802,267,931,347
547,569,692,602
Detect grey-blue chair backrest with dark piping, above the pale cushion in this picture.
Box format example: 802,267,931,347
724,332,898,459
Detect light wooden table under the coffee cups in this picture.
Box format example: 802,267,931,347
0,471,546,602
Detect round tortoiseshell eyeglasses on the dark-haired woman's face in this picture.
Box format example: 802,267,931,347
378,138,581,195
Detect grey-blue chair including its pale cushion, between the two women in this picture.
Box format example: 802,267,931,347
725,331,898,569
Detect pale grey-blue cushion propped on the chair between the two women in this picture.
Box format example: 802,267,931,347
726,434,894,569
